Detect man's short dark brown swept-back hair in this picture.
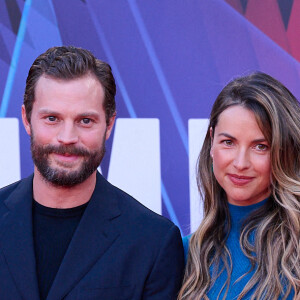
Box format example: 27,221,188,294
24,46,116,124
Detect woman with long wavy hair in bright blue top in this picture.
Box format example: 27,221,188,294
178,73,300,300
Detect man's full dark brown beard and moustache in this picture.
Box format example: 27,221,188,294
31,131,105,187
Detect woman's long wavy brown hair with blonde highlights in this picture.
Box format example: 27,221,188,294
178,72,300,300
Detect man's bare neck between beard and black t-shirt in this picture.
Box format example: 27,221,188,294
33,168,96,208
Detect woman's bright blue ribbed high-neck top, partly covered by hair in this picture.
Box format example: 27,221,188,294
183,199,294,300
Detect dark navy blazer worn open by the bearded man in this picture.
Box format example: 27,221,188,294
0,174,184,300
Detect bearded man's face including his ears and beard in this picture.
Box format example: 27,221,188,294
22,75,114,187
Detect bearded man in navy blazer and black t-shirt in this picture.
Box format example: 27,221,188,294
0,47,183,300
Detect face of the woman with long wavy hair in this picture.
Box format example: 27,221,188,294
211,105,271,206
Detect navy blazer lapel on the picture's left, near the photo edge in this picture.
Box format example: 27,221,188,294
0,176,39,300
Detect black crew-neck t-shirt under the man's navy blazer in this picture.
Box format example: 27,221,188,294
32,200,88,299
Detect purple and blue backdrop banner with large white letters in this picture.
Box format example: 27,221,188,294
0,0,300,235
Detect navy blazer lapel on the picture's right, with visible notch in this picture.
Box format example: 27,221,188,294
47,174,120,300
